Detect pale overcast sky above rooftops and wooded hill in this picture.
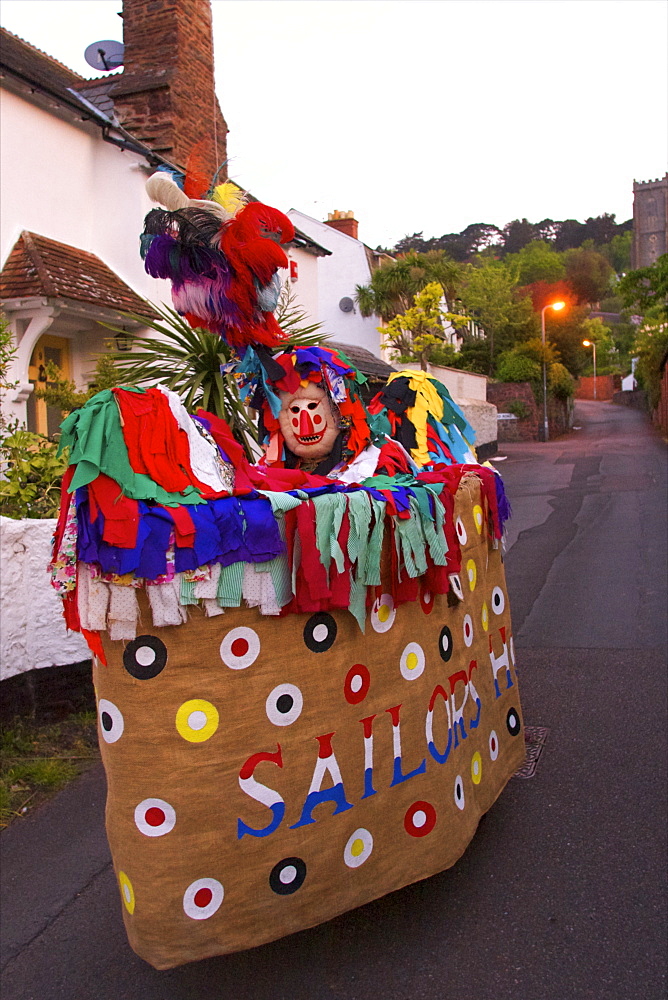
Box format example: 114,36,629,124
0,0,668,246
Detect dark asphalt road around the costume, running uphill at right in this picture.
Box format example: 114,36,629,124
0,403,668,1000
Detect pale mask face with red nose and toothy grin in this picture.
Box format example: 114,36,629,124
278,382,339,459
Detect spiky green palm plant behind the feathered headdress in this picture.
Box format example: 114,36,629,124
104,283,324,457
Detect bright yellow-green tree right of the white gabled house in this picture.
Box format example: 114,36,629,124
379,281,467,371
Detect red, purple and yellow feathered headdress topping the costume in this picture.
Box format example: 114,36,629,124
141,164,294,351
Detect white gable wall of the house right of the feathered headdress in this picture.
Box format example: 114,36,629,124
287,208,380,357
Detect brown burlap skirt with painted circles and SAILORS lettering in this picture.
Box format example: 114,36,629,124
94,490,524,969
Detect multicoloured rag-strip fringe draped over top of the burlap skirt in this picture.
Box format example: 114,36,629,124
51,378,509,657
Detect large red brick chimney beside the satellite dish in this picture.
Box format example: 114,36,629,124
112,0,227,181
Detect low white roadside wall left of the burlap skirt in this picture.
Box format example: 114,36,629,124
0,517,90,680
